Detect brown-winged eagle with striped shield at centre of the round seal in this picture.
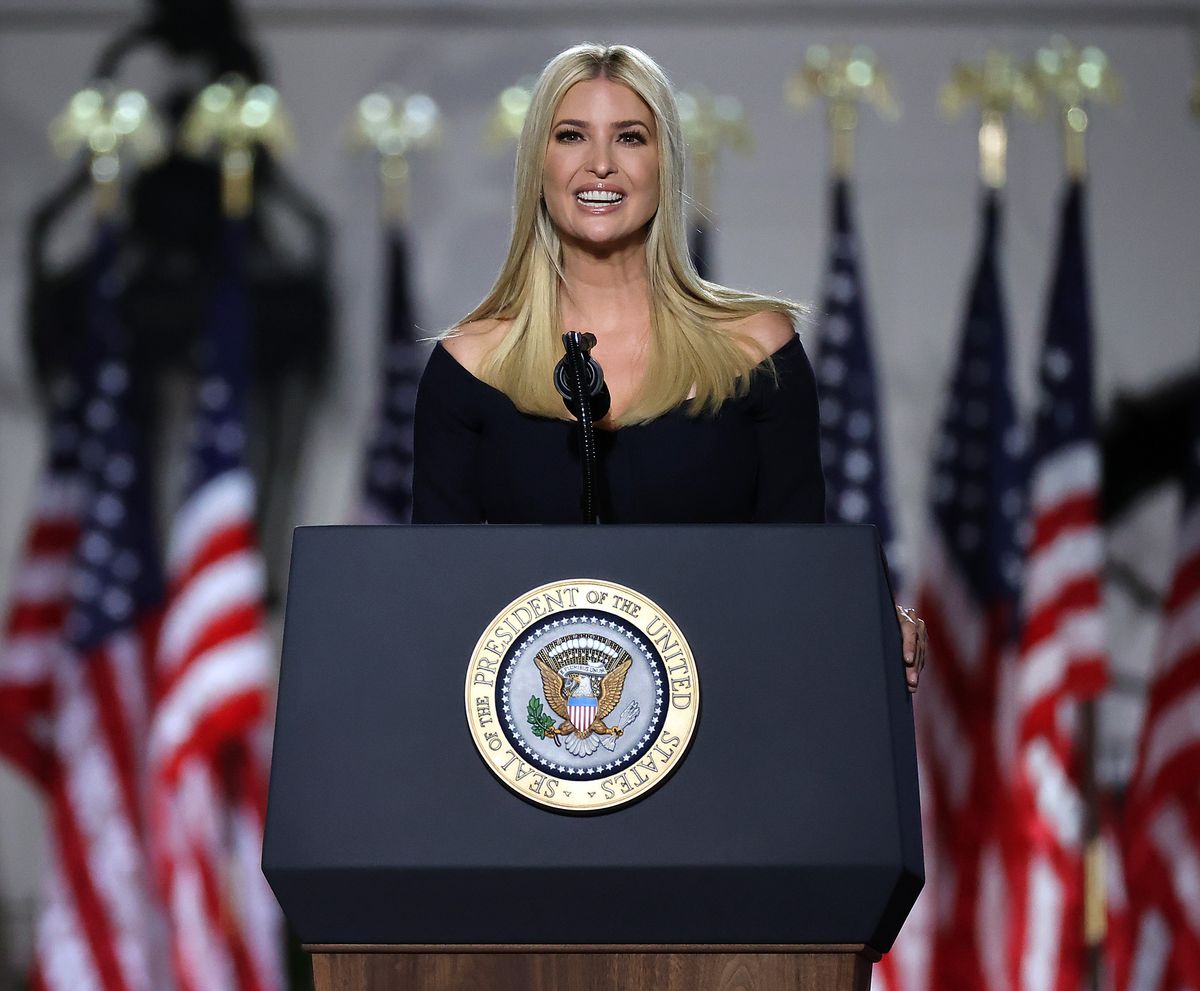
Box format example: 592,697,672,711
534,633,641,757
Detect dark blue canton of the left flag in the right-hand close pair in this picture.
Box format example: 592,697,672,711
931,192,1026,619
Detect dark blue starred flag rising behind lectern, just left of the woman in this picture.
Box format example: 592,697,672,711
362,224,421,523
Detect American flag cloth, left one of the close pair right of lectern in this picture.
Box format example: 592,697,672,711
883,191,1025,991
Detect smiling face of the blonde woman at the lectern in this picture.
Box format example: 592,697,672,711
541,77,659,253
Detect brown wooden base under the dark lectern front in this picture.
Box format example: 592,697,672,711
305,944,878,991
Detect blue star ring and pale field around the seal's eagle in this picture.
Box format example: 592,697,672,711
498,609,670,781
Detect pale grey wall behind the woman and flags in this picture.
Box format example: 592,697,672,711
0,0,1200,963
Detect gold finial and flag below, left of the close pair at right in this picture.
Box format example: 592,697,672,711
912,50,1037,991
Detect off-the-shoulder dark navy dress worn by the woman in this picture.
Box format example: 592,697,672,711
413,337,824,523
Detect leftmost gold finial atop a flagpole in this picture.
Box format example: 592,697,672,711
49,83,164,216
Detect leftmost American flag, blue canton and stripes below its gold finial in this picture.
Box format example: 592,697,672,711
18,223,162,991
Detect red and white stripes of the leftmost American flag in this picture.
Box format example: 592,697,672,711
0,473,161,991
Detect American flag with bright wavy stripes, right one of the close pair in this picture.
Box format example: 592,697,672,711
1013,181,1106,991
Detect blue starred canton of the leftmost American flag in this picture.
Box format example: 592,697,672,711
64,223,164,655
